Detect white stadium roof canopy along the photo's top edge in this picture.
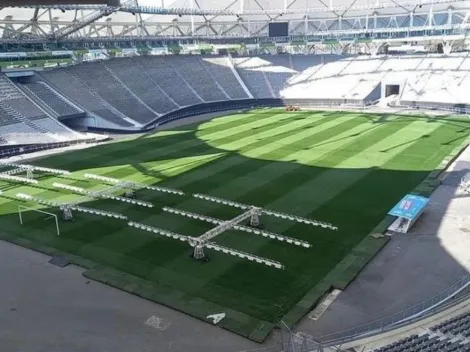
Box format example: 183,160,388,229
0,0,470,38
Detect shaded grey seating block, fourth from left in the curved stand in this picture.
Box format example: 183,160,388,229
105,58,178,114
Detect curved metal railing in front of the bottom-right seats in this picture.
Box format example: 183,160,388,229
317,275,470,346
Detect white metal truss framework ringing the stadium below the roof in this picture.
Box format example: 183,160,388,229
0,0,470,43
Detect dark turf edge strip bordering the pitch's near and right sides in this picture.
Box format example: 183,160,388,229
0,129,470,343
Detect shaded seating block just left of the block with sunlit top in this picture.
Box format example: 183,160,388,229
171,55,228,102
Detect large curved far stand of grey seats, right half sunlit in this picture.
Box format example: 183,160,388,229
17,53,470,129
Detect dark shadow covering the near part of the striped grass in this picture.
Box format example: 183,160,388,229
0,112,465,336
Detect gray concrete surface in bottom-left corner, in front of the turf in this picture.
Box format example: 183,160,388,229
0,241,262,352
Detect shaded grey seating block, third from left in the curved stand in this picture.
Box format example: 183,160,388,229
66,62,157,123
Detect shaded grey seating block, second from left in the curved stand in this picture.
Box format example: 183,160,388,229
40,69,132,127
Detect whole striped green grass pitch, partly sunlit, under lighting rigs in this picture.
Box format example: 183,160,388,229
0,109,470,340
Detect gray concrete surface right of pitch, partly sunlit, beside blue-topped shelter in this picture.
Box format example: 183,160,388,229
297,149,470,340
